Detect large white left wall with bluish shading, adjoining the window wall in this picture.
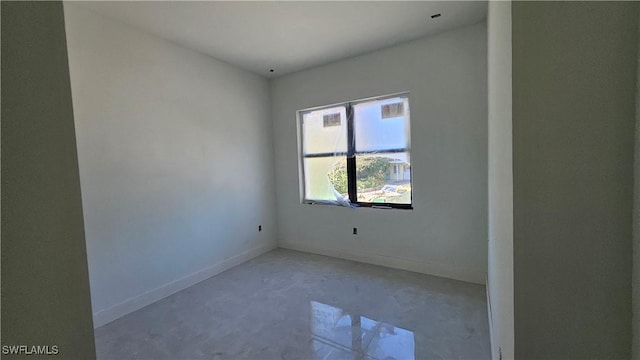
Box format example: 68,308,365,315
65,3,276,325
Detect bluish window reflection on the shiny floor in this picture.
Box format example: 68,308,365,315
311,301,415,360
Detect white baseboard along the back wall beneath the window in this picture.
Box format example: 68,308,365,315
278,241,487,285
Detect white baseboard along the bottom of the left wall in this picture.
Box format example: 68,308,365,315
93,244,278,328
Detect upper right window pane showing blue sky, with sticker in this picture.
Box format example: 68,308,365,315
353,97,410,152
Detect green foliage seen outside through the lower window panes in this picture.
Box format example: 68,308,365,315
328,156,390,194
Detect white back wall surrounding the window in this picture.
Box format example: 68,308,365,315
271,23,487,283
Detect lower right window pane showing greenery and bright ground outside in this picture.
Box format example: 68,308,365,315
356,152,411,204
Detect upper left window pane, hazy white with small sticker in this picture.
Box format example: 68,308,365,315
302,106,347,155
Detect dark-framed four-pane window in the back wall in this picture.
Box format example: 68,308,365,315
298,94,412,209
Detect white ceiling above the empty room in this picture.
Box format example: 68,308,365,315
75,1,487,77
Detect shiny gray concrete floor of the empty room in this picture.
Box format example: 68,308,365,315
96,249,491,360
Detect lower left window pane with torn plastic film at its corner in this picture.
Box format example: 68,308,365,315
304,156,349,201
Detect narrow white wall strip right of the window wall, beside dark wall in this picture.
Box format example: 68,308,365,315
487,1,514,359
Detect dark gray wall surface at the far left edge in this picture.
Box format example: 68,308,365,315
1,1,95,359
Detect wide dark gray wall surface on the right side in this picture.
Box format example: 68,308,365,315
512,1,638,359
